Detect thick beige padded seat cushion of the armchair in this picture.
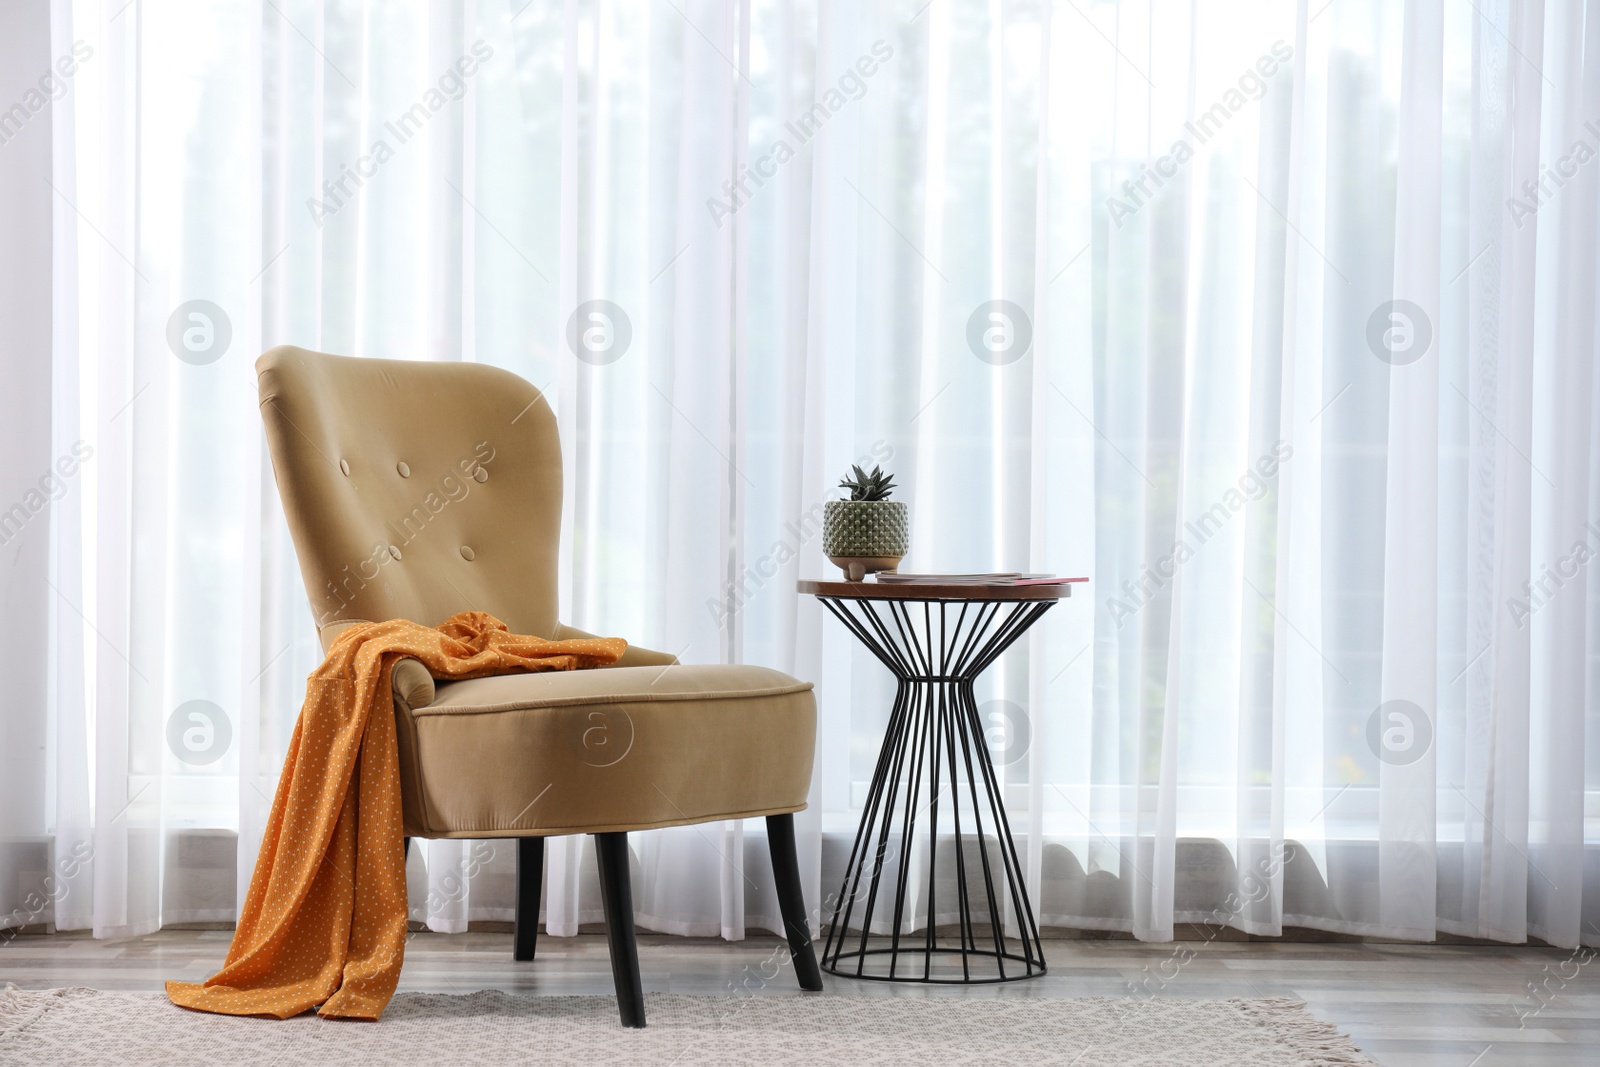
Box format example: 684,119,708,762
395,664,816,838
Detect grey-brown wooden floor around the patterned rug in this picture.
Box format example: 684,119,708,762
0,929,1600,1067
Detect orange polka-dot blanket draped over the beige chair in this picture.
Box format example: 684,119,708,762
166,611,627,1019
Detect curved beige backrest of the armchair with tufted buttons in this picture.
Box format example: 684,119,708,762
256,346,562,637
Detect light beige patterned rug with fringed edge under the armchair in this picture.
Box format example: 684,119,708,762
0,985,1373,1067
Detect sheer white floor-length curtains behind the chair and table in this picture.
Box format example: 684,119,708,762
0,0,1600,945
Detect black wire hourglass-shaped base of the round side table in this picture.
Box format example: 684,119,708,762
819,595,1056,982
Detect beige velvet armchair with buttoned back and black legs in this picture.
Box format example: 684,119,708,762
256,347,822,1027
